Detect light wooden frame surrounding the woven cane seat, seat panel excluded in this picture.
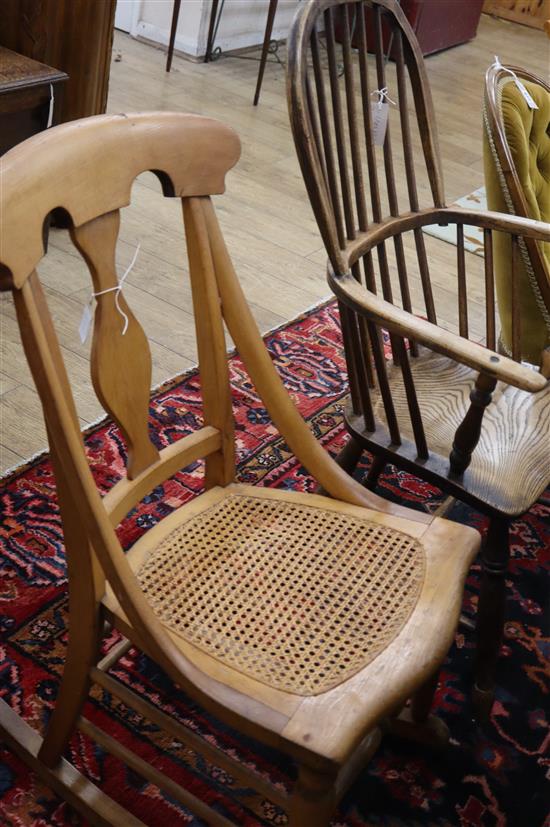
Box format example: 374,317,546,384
0,113,479,827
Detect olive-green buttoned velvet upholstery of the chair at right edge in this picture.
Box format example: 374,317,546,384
483,75,550,365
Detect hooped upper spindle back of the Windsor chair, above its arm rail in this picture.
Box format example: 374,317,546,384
288,0,444,278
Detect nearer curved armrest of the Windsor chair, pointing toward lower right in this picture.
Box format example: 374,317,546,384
328,272,547,393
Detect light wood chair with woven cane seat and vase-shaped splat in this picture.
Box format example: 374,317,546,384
0,112,480,827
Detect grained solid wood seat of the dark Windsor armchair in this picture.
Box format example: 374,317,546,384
367,348,550,516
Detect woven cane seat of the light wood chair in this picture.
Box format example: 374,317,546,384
104,485,479,764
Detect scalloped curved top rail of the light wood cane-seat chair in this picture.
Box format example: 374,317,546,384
0,112,240,290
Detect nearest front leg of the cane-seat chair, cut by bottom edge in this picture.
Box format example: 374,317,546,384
288,767,337,827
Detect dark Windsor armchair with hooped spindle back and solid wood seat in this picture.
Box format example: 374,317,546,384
287,0,550,716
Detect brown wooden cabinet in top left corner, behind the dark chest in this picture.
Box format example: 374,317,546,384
0,0,116,122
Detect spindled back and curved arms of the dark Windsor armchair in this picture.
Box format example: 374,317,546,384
287,0,545,474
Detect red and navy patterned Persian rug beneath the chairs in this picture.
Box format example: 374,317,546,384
0,304,550,827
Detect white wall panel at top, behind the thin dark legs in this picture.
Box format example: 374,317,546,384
131,0,298,57
